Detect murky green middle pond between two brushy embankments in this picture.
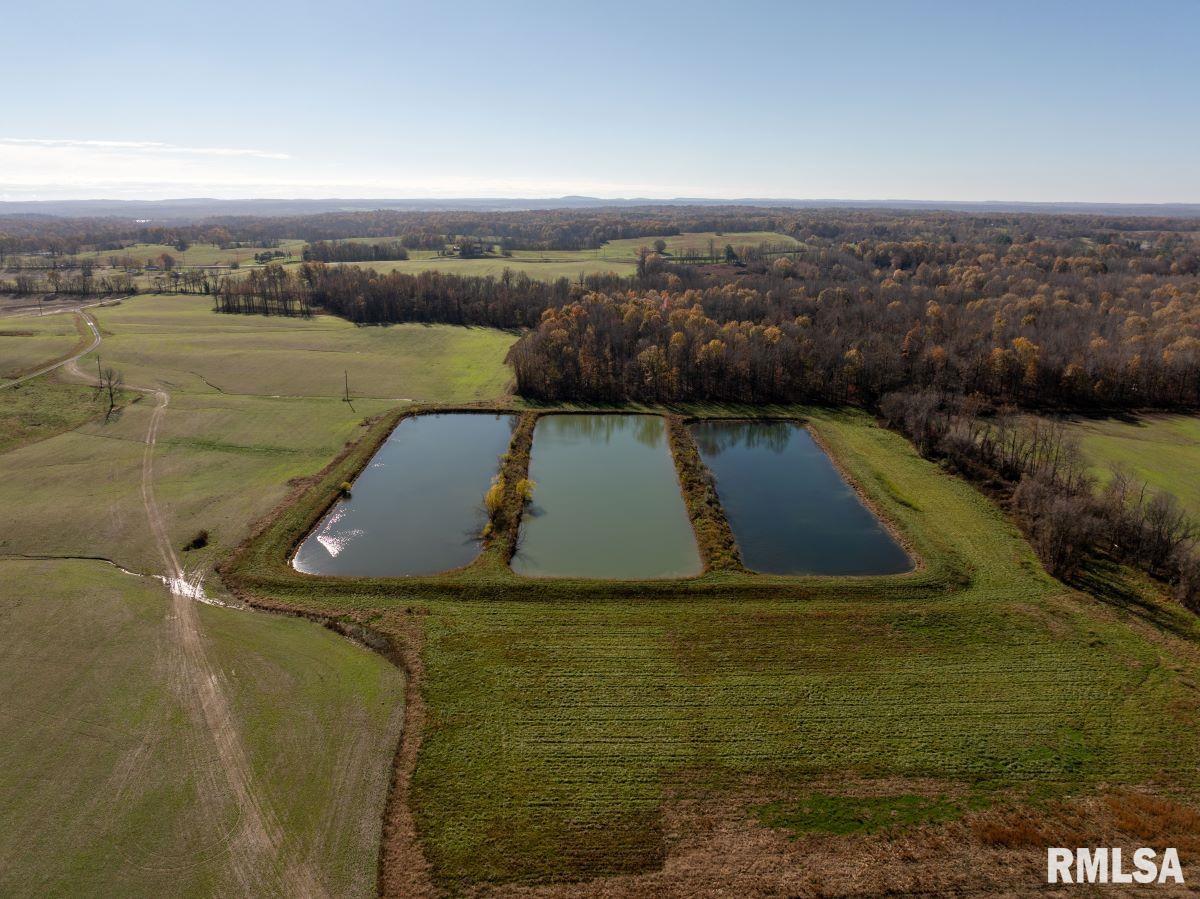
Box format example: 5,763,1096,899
512,415,702,580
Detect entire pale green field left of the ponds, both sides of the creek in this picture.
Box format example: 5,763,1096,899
0,296,514,895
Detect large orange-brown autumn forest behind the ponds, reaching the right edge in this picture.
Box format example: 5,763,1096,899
512,224,1200,408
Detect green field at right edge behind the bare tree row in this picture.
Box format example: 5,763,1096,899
1070,415,1200,520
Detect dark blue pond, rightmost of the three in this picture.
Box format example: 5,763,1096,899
691,421,913,575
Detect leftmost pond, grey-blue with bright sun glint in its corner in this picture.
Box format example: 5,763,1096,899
292,414,516,577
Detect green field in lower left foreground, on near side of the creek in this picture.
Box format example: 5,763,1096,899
0,559,403,897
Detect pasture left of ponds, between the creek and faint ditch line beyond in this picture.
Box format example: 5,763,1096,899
0,394,400,571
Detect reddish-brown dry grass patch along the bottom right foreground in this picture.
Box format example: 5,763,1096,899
472,779,1200,899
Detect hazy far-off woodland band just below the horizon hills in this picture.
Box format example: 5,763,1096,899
9,205,1200,262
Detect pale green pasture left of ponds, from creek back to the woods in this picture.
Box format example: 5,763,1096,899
0,296,512,570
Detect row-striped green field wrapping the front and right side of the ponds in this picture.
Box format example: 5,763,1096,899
243,408,1200,894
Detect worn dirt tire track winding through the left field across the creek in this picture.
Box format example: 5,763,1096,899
54,313,326,897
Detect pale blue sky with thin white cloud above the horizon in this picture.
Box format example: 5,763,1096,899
9,0,1200,203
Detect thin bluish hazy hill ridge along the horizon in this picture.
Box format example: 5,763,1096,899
7,197,1200,222
